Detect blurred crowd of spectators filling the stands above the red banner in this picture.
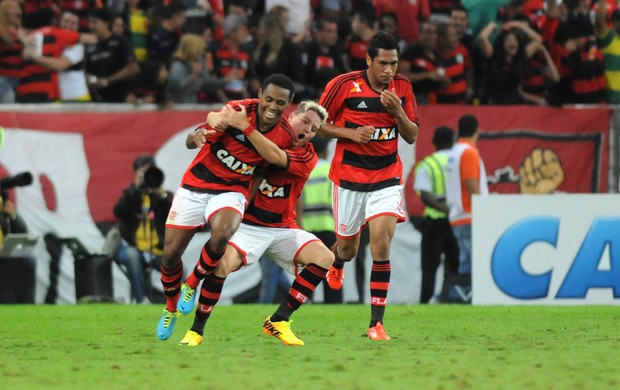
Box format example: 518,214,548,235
0,0,620,108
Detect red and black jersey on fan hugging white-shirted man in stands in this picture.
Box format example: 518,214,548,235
17,27,80,103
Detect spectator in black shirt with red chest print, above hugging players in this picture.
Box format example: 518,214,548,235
304,19,349,98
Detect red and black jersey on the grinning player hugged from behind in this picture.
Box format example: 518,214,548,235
181,99,293,197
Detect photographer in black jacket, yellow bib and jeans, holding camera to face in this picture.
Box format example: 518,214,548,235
113,155,173,303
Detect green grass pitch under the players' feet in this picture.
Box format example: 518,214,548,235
0,304,620,390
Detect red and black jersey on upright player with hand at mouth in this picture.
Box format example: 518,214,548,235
320,71,418,191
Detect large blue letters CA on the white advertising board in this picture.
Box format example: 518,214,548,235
491,216,620,299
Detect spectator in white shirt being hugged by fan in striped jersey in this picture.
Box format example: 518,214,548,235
25,11,91,102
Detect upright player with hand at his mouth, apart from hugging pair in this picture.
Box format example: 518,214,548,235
319,31,418,340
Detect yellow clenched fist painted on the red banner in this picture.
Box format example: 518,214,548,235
519,148,564,194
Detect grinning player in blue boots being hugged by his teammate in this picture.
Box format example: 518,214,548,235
157,74,294,340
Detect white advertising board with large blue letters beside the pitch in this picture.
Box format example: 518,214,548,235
472,194,620,305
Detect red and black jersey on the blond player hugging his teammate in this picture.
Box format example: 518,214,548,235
243,143,318,228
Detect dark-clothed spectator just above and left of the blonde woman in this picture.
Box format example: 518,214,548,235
147,0,187,67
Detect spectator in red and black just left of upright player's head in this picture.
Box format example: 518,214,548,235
346,3,377,70
